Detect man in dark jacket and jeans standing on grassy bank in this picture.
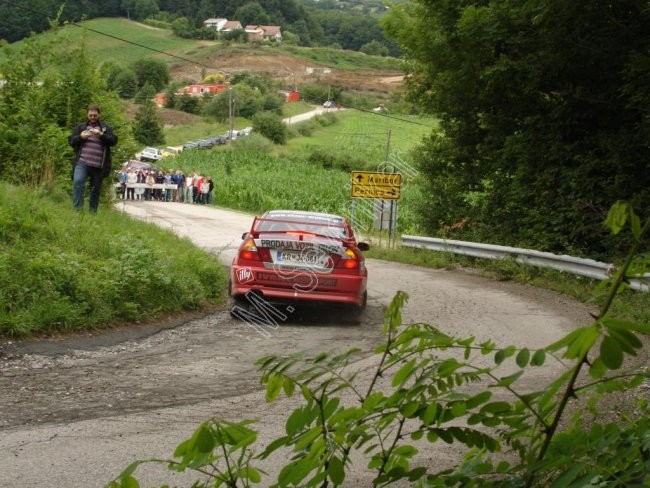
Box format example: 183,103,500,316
68,105,117,213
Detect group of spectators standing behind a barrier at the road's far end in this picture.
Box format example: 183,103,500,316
118,168,214,204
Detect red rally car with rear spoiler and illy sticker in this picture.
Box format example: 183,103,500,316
230,210,370,312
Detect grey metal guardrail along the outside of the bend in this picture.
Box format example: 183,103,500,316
402,235,650,292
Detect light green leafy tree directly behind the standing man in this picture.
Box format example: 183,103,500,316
0,30,130,185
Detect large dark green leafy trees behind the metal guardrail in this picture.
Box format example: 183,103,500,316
385,0,650,259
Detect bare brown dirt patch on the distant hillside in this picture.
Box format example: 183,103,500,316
171,51,404,93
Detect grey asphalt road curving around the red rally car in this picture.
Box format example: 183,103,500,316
0,201,589,488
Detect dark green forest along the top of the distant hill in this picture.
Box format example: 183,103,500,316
0,0,399,55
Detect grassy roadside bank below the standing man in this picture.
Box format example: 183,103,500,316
0,183,226,337
